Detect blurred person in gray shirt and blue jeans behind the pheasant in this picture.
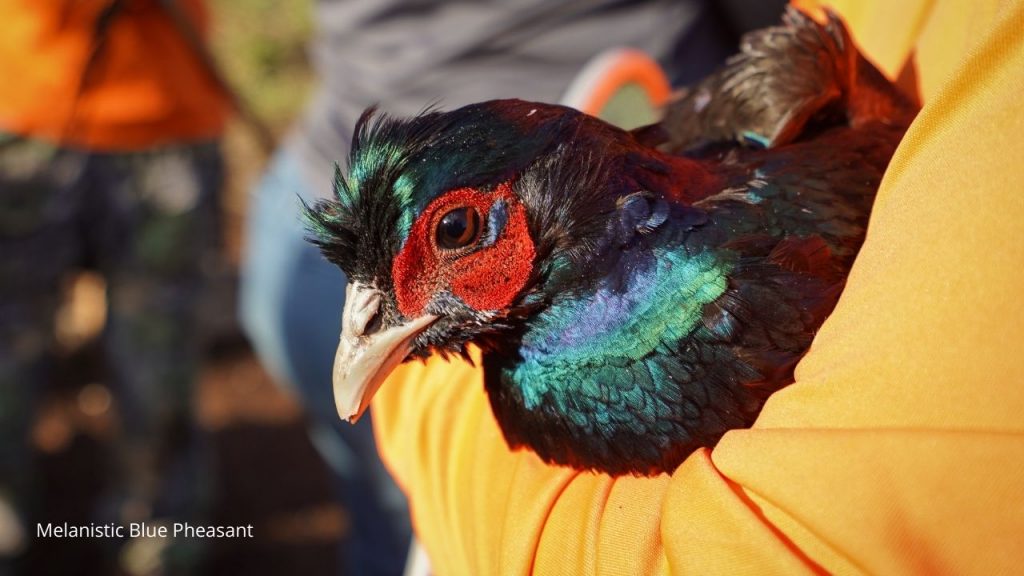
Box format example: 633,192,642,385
241,0,783,575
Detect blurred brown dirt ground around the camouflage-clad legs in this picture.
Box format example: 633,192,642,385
28,330,347,576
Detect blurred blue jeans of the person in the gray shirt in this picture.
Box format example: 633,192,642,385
241,148,411,575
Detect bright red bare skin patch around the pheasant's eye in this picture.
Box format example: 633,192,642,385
391,182,536,318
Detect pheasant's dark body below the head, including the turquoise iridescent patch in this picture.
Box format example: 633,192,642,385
484,120,898,472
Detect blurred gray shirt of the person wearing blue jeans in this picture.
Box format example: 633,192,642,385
289,0,695,196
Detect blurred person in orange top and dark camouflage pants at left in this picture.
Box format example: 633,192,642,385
0,0,228,574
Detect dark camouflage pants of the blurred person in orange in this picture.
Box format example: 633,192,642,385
0,135,222,522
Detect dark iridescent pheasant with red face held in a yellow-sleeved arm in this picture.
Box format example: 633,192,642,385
308,10,915,475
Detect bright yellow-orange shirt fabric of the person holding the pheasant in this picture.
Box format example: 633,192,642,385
373,0,1024,576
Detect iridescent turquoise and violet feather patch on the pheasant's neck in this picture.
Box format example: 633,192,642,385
506,251,727,409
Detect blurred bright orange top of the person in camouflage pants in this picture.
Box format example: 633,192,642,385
0,0,228,151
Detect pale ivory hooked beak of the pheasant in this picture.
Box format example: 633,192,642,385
334,282,437,422
